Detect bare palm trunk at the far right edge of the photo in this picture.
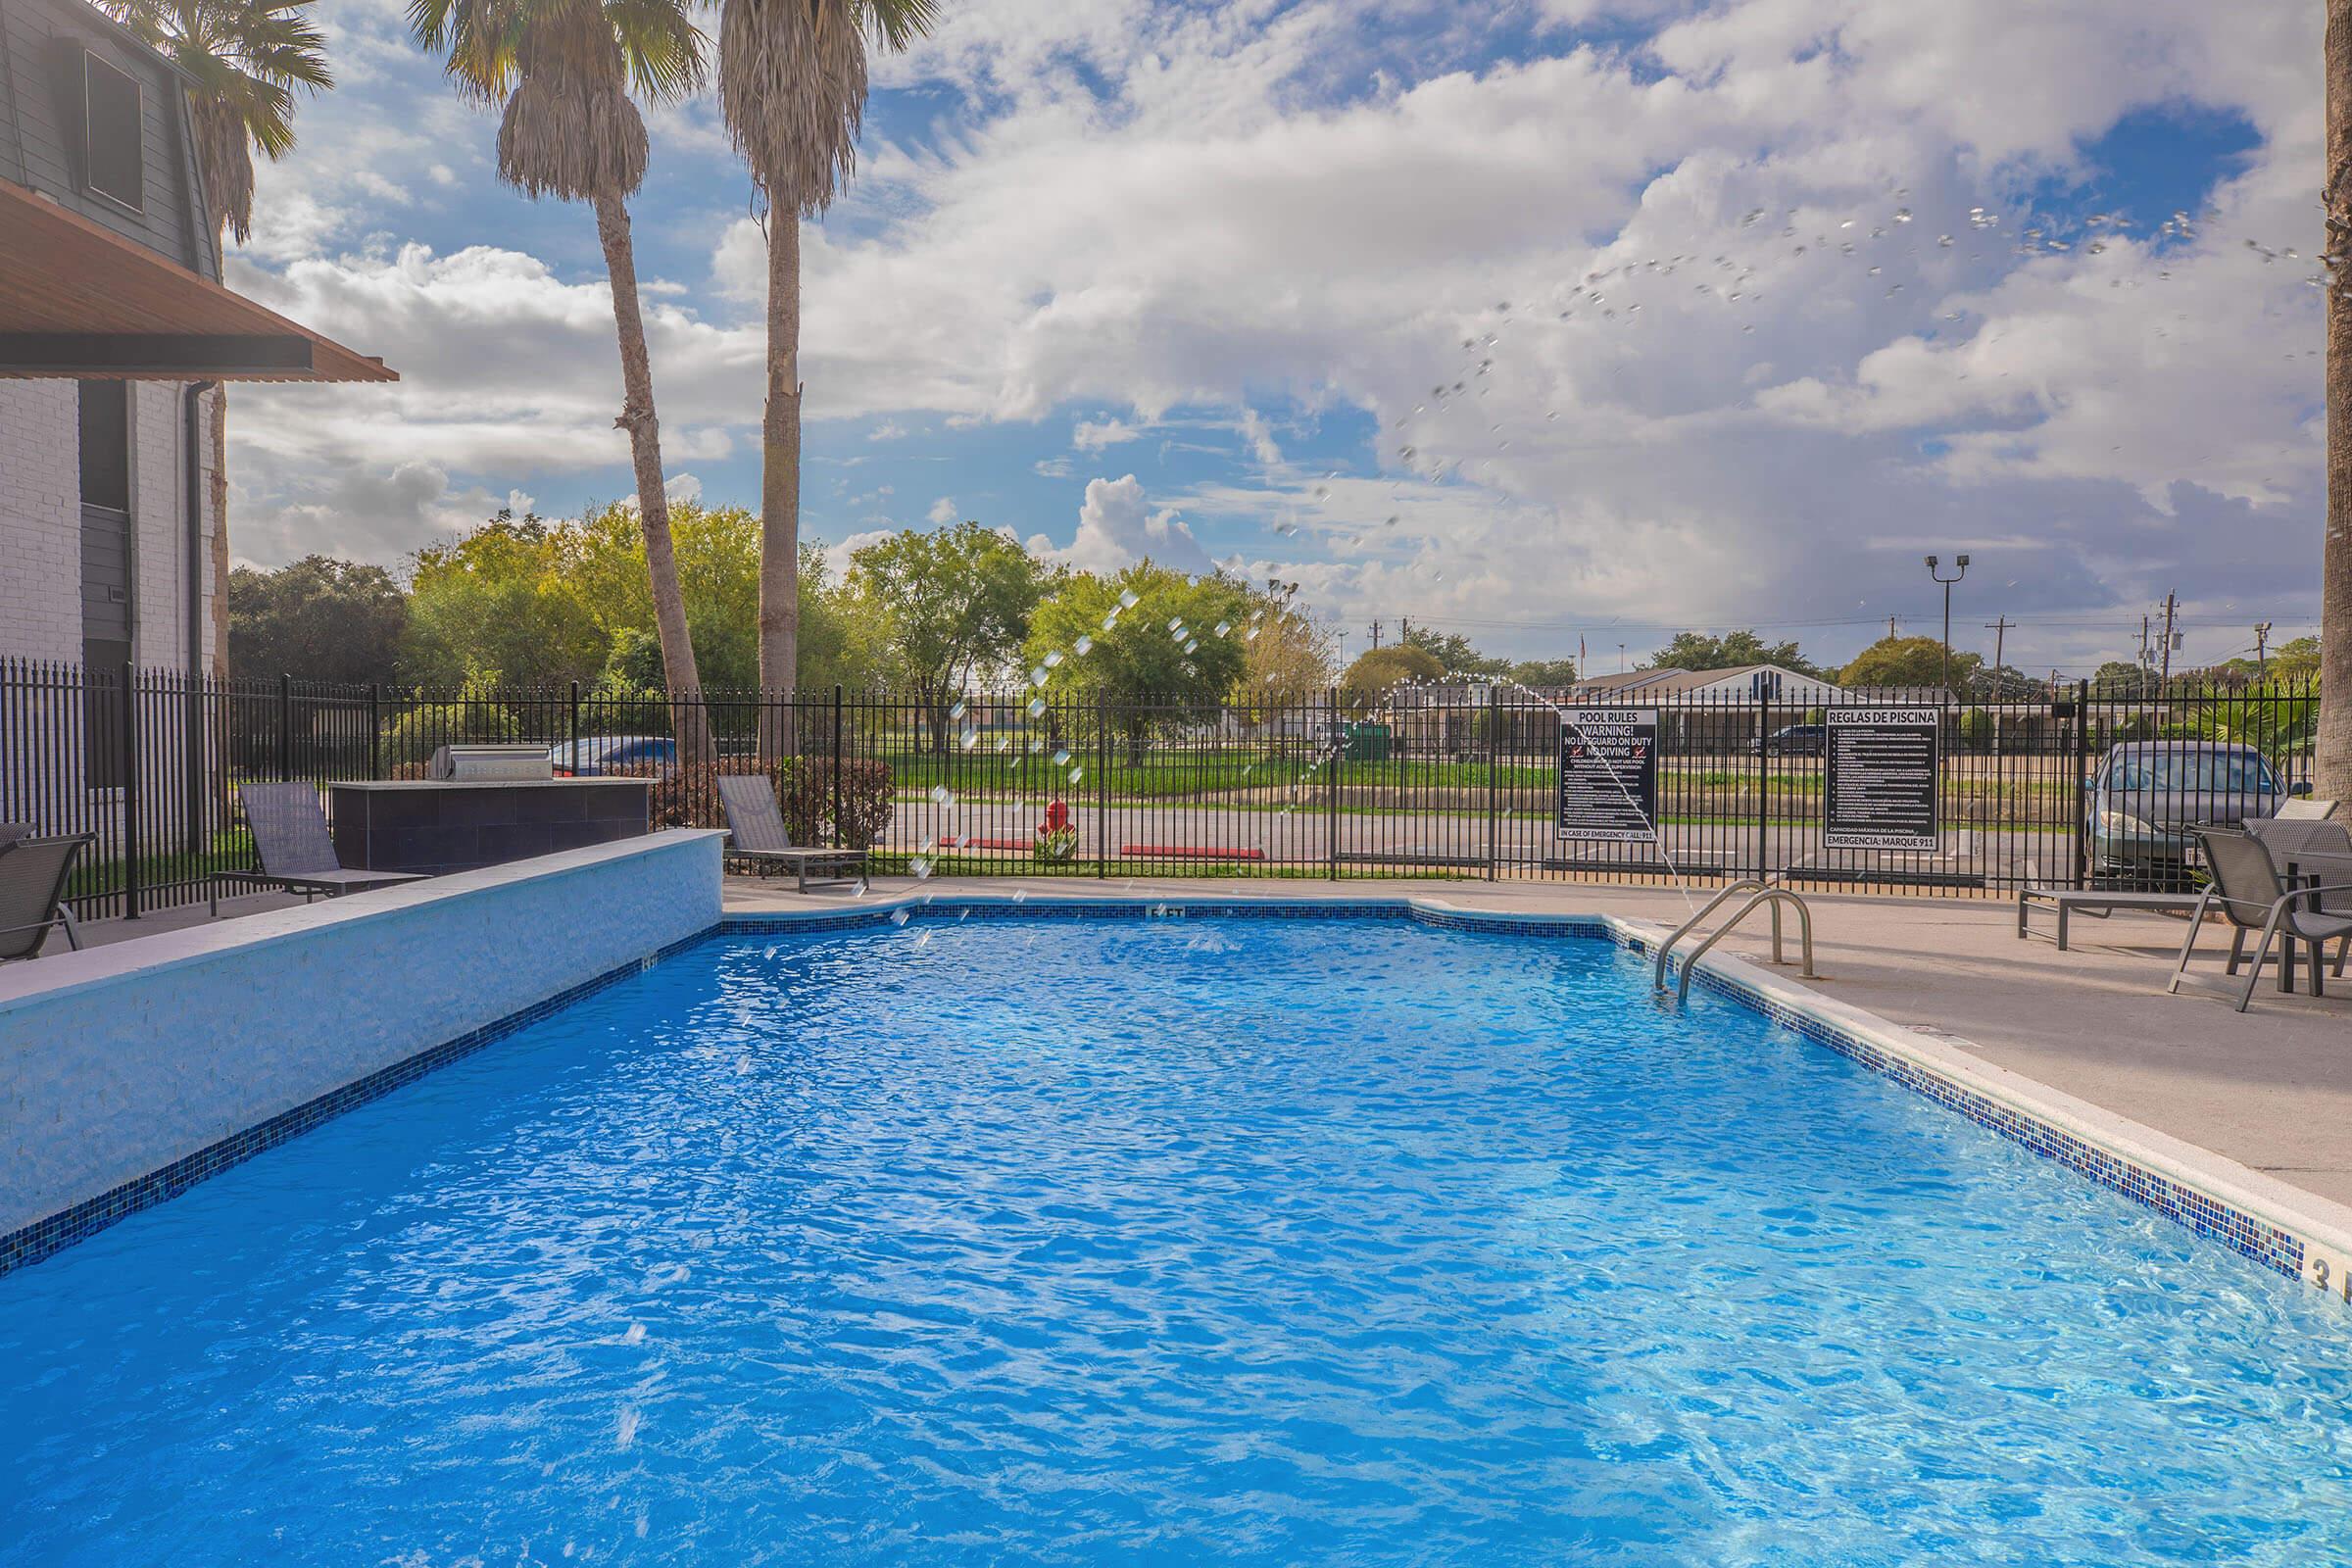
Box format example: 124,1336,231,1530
2312,0,2352,800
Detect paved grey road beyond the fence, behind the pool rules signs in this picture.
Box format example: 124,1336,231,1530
884,800,2075,884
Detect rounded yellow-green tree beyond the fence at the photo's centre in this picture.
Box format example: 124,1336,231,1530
1028,562,1249,761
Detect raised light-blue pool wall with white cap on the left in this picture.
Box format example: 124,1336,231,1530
0,830,724,1237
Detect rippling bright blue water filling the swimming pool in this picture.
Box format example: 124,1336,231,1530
0,919,2352,1568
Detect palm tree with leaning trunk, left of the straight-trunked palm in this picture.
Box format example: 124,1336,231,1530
410,0,708,753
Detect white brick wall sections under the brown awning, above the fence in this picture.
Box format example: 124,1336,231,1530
0,381,214,670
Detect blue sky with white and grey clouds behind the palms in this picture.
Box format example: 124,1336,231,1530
233,0,2322,670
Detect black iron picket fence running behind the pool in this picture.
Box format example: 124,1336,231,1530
0,661,2317,917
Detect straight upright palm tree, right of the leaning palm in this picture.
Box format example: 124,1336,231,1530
719,0,934,691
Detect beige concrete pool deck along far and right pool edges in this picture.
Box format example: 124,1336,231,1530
727,877,2352,1203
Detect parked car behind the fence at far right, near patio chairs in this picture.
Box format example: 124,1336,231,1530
2083,741,2312,891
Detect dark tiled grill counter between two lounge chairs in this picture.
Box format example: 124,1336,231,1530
327,778,654,877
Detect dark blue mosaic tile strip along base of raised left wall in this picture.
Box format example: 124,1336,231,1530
0,926,722,1274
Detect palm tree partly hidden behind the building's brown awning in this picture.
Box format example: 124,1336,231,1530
106,0,334,677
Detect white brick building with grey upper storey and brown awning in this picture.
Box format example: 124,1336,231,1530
0,0,395,808
